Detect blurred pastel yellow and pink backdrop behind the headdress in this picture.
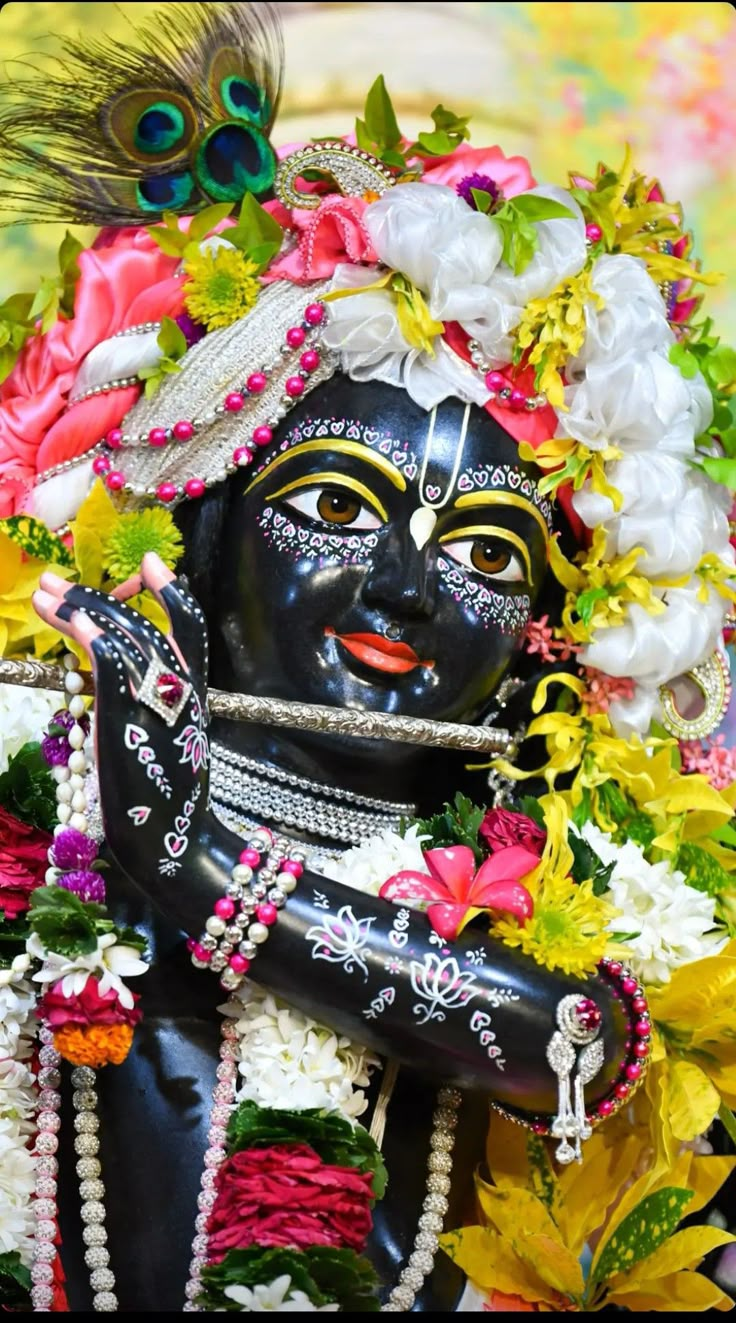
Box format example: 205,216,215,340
0,0,736,340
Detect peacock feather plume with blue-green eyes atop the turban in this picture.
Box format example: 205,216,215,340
0,0,283,226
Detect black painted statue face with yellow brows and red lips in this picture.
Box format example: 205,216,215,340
210,376,551,721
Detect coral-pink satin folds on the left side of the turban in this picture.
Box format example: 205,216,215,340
0,229,183,517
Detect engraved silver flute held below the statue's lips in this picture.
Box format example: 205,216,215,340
0,660,516,757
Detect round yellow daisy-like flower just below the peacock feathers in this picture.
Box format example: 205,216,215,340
184,247,261,331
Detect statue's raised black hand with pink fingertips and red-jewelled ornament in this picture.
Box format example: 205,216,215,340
33,553,209,892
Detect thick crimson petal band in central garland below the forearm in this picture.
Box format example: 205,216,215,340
208,1144,373,1262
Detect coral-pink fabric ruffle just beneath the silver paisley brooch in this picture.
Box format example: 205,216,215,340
265,193,377,284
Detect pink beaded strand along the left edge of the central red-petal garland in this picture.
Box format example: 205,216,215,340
184,1000,238,1314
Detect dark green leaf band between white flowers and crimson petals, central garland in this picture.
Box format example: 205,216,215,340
228,1102,388,1199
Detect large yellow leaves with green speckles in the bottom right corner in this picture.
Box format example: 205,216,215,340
441,1109,736,1312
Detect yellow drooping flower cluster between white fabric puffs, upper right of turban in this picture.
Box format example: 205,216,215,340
516,271,604,409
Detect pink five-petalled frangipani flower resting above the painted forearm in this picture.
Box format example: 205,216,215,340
379,845,539,941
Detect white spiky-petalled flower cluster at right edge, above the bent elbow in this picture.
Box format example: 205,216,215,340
581,823,728,983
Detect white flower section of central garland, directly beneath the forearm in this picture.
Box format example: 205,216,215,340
227,983,380,1121
